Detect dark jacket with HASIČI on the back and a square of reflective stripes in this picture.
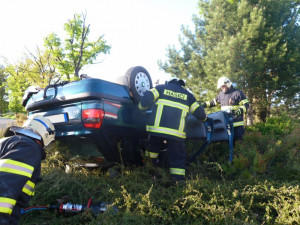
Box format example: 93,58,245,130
139,83,206,140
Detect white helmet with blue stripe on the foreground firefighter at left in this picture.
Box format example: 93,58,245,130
10,115,55,146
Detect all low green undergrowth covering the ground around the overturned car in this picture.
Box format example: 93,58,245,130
0,115,300,225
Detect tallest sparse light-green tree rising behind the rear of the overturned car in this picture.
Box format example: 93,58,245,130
44,14,111,80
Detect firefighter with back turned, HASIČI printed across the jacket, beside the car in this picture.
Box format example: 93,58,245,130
139,78,206,181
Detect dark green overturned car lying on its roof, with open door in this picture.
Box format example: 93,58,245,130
23,66,234,164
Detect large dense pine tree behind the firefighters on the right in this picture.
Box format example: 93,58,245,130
159,0,300,121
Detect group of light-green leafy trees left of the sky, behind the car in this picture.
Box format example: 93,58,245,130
0,14,110,113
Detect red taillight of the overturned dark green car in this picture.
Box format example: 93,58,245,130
82,109,104,128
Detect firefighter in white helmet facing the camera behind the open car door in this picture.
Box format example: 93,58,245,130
200,77,249,142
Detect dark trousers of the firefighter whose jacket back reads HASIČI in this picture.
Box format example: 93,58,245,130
149,135,186,181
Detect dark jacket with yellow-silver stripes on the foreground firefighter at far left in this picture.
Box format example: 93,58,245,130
0,135,45,224
